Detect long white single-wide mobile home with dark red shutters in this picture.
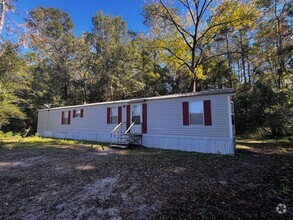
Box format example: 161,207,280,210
38,89,235,154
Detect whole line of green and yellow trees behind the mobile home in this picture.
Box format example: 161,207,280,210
0,0,293,135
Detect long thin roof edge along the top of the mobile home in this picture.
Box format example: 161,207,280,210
38,88,235,112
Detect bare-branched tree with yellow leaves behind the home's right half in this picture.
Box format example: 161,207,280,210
145,0,251,92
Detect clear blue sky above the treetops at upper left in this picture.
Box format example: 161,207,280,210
9,0,146,36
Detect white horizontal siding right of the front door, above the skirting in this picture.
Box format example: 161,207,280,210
148,95,229,137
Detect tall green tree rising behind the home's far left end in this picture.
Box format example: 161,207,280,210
26,7,75,105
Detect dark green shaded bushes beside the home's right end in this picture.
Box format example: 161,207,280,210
235,83,293,136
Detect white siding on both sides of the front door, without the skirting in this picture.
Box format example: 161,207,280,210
39,95,231,137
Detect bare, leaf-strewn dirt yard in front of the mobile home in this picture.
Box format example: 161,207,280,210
0,138,293,219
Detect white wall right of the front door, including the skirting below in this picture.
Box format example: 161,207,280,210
142,95,234,154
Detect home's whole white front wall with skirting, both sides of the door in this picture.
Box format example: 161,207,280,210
38,94,234,154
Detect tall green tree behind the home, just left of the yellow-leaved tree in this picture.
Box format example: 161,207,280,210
88,12,143,100
